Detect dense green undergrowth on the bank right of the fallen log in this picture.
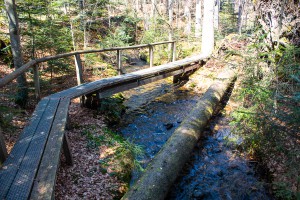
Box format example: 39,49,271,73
231,32,300,199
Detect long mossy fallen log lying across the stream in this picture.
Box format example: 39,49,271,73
122,70,236,200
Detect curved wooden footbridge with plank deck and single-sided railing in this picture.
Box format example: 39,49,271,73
0,41,208,200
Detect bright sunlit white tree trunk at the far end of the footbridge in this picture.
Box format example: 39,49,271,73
201,0,215,55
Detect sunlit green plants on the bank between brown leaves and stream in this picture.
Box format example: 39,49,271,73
82,127,143,182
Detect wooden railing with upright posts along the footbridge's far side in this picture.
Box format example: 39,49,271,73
0,41,176,99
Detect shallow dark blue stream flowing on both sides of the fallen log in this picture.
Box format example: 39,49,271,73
114,62,271,200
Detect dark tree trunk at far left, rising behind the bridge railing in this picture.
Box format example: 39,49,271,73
4,0,28,107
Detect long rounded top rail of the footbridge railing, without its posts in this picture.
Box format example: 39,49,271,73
0,41,176,88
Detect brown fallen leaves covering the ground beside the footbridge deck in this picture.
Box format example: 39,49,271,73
55,103,126,200
